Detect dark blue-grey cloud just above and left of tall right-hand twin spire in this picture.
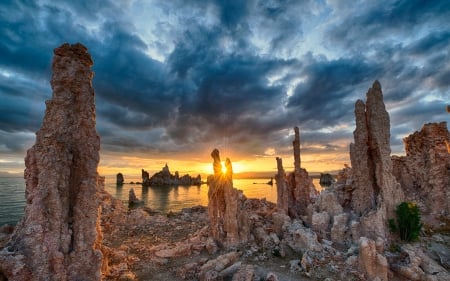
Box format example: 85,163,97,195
288,57,382,128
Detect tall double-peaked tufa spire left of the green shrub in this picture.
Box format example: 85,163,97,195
350,81,404,238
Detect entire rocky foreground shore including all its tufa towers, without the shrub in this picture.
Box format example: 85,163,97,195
0,44,450,281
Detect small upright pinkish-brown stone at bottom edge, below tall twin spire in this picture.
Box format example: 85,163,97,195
359,237,389,281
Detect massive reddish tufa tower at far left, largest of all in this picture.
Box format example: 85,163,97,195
0,44,102,280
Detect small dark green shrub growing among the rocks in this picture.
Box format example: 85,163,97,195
389,202,423,241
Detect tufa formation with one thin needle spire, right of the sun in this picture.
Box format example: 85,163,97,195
275,127,318,218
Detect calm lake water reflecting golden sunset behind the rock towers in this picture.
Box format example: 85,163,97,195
0,176,320,225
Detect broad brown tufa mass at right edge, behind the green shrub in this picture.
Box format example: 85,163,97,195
392,122,450,216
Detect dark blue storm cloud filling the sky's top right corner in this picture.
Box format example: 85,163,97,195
328,0,450,49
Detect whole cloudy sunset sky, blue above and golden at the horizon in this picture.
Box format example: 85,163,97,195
0,0,450,175
